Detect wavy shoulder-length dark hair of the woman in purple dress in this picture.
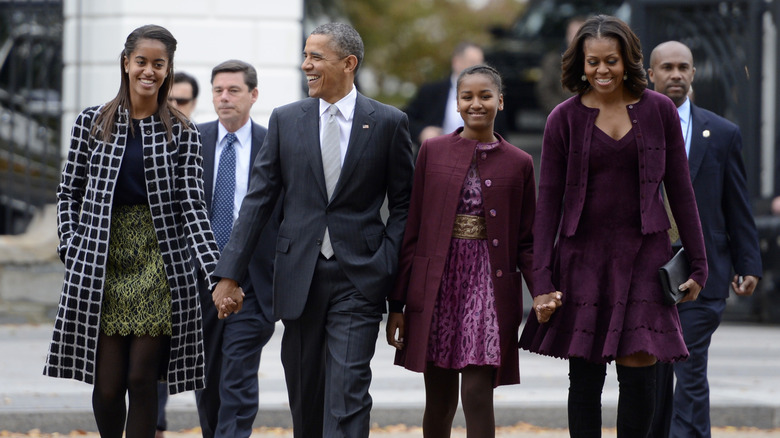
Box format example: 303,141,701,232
561,15,647,97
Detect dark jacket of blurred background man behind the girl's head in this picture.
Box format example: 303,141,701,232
404,76,507,143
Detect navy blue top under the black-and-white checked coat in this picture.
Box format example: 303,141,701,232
114,119,149,205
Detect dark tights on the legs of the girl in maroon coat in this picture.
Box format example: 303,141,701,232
423,364,496,438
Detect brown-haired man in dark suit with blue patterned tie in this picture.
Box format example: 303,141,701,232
196,60,279,438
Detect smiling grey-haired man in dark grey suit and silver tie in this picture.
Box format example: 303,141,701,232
207,23,413,438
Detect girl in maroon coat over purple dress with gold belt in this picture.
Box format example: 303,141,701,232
387,65,536,438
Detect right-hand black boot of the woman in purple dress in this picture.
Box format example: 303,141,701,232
617,365,656,438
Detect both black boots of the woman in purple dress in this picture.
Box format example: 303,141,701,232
569,358,655,438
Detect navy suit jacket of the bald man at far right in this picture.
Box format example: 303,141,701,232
688,104,762,299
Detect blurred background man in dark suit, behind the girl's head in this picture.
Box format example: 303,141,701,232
405,42,485,146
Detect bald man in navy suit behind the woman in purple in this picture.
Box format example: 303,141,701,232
648,41,762,438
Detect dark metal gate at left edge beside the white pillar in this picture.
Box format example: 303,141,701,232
0,0,63,234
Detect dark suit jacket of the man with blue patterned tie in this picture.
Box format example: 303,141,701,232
198,120,281,321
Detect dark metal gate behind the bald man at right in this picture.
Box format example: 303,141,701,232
631,0,770,199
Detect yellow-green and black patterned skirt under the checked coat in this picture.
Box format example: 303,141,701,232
100,205,171,336
